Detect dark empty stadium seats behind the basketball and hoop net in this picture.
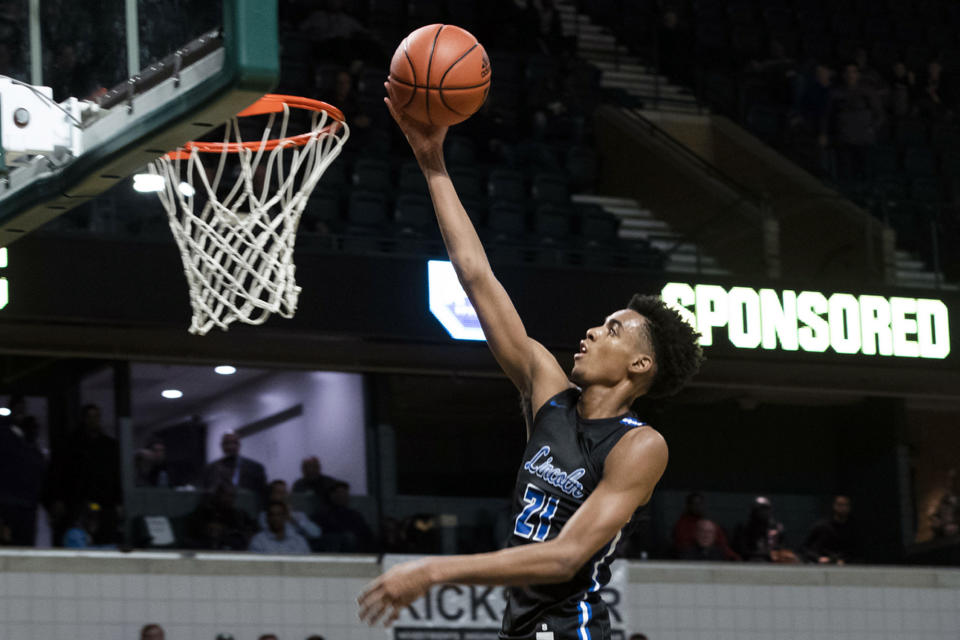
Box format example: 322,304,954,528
39,0,676,270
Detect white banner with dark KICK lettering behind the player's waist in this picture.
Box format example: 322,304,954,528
382,555,630,640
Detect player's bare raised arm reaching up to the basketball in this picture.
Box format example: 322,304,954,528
384,83,570,411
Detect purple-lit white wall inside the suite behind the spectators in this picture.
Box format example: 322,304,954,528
199,371,367,495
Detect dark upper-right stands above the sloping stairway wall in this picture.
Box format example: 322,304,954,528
579,0,960,277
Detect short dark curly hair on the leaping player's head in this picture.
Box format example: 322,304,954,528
627,294,704,398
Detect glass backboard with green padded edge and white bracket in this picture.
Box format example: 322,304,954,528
0,0,279,247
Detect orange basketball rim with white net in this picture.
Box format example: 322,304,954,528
150,94,350,335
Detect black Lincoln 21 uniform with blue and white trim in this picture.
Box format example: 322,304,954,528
500,388,644,640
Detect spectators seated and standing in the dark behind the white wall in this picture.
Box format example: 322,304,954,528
0,397,960,564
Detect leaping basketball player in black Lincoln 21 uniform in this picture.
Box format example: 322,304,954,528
359,88,703,640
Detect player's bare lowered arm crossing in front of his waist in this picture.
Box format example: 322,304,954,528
360,428,667,625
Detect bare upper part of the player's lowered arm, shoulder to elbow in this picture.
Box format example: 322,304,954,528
550,427,667,573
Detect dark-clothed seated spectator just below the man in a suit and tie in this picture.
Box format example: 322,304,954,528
185,482,257,551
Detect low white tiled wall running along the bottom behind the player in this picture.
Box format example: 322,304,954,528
0,550,960,640
